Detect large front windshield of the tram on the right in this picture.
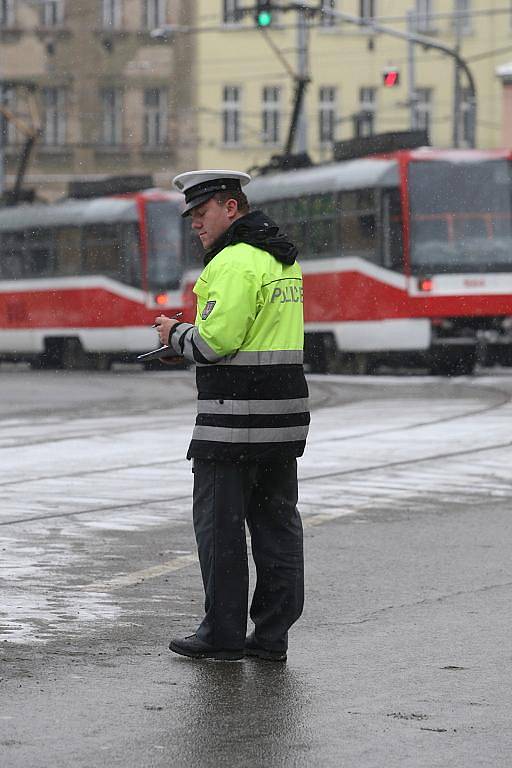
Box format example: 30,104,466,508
409,159,512,274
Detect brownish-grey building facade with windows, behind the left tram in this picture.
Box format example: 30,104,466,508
0,0,196,200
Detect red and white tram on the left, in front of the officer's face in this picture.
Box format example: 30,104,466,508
0,189,184,368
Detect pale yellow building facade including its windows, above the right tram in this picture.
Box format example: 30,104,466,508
197,0,512,168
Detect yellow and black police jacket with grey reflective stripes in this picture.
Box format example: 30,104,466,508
169,243,309,461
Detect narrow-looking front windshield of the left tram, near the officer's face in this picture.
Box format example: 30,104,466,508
146,200,183,291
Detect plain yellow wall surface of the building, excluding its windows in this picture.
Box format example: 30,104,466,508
196,0,512,169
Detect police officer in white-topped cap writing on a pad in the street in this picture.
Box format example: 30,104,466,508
156,171,309,661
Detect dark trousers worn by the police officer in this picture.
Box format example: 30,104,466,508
193,459,304,650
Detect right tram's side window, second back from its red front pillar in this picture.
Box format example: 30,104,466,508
340,190,379,261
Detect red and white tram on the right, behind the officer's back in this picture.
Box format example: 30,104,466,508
247,148,512,374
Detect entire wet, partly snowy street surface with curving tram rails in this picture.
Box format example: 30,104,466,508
0,370,512,768
